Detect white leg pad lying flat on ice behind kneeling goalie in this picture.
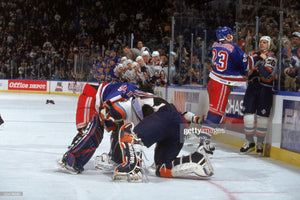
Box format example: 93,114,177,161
156,147,214,178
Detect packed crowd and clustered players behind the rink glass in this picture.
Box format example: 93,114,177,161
0,0,300,91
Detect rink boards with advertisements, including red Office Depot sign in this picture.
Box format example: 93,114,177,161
0,80,300,167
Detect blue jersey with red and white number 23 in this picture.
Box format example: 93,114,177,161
209,42,255,87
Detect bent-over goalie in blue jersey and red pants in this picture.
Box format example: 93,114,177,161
59,83,145,173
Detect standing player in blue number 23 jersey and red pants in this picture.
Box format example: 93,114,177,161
200,26,254,154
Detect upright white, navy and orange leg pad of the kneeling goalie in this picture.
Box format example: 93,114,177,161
113,123,143,181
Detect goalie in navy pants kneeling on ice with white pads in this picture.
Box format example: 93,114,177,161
105,96,213,181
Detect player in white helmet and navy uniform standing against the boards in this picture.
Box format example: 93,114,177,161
240,36,277,154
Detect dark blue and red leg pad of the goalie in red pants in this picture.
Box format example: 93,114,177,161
62,116,104,173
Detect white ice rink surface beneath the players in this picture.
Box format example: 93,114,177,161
0,93,300,200
